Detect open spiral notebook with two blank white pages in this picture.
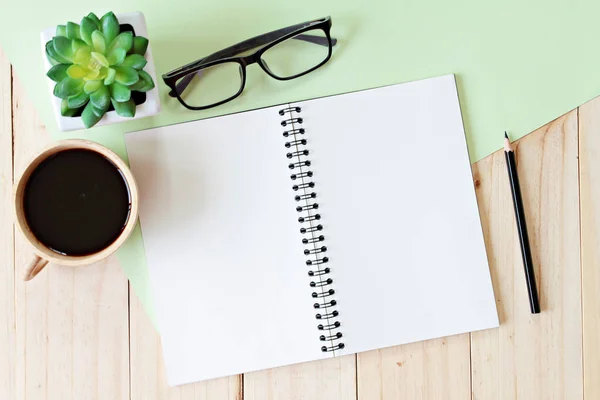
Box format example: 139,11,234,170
126,75,498,385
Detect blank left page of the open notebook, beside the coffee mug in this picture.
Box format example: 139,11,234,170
126,107,331,385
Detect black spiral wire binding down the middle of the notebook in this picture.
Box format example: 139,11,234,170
279,106,345,352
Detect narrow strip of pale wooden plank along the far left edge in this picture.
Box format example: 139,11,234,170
0,49,15,399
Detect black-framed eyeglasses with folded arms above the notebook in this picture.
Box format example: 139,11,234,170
162,17,337,110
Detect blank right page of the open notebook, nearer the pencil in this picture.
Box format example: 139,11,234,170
293,75,498,355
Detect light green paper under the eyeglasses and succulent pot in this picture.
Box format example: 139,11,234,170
0,0,600,324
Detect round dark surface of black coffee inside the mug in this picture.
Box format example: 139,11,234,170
23,150,130,256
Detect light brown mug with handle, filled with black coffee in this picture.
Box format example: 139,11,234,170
14,139,138,280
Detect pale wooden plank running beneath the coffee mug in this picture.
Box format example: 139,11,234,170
13,78,129,400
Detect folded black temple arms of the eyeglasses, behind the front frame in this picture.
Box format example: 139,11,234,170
169,24,337,97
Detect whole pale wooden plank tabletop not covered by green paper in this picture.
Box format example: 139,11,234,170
0,50,600,400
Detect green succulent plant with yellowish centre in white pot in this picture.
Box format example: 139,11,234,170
46,12,154,128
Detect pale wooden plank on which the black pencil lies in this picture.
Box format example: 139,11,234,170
471,110,583,400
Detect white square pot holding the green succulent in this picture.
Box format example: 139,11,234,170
41,12,160,131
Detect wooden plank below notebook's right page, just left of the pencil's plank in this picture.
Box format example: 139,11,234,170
358,334,471,399
